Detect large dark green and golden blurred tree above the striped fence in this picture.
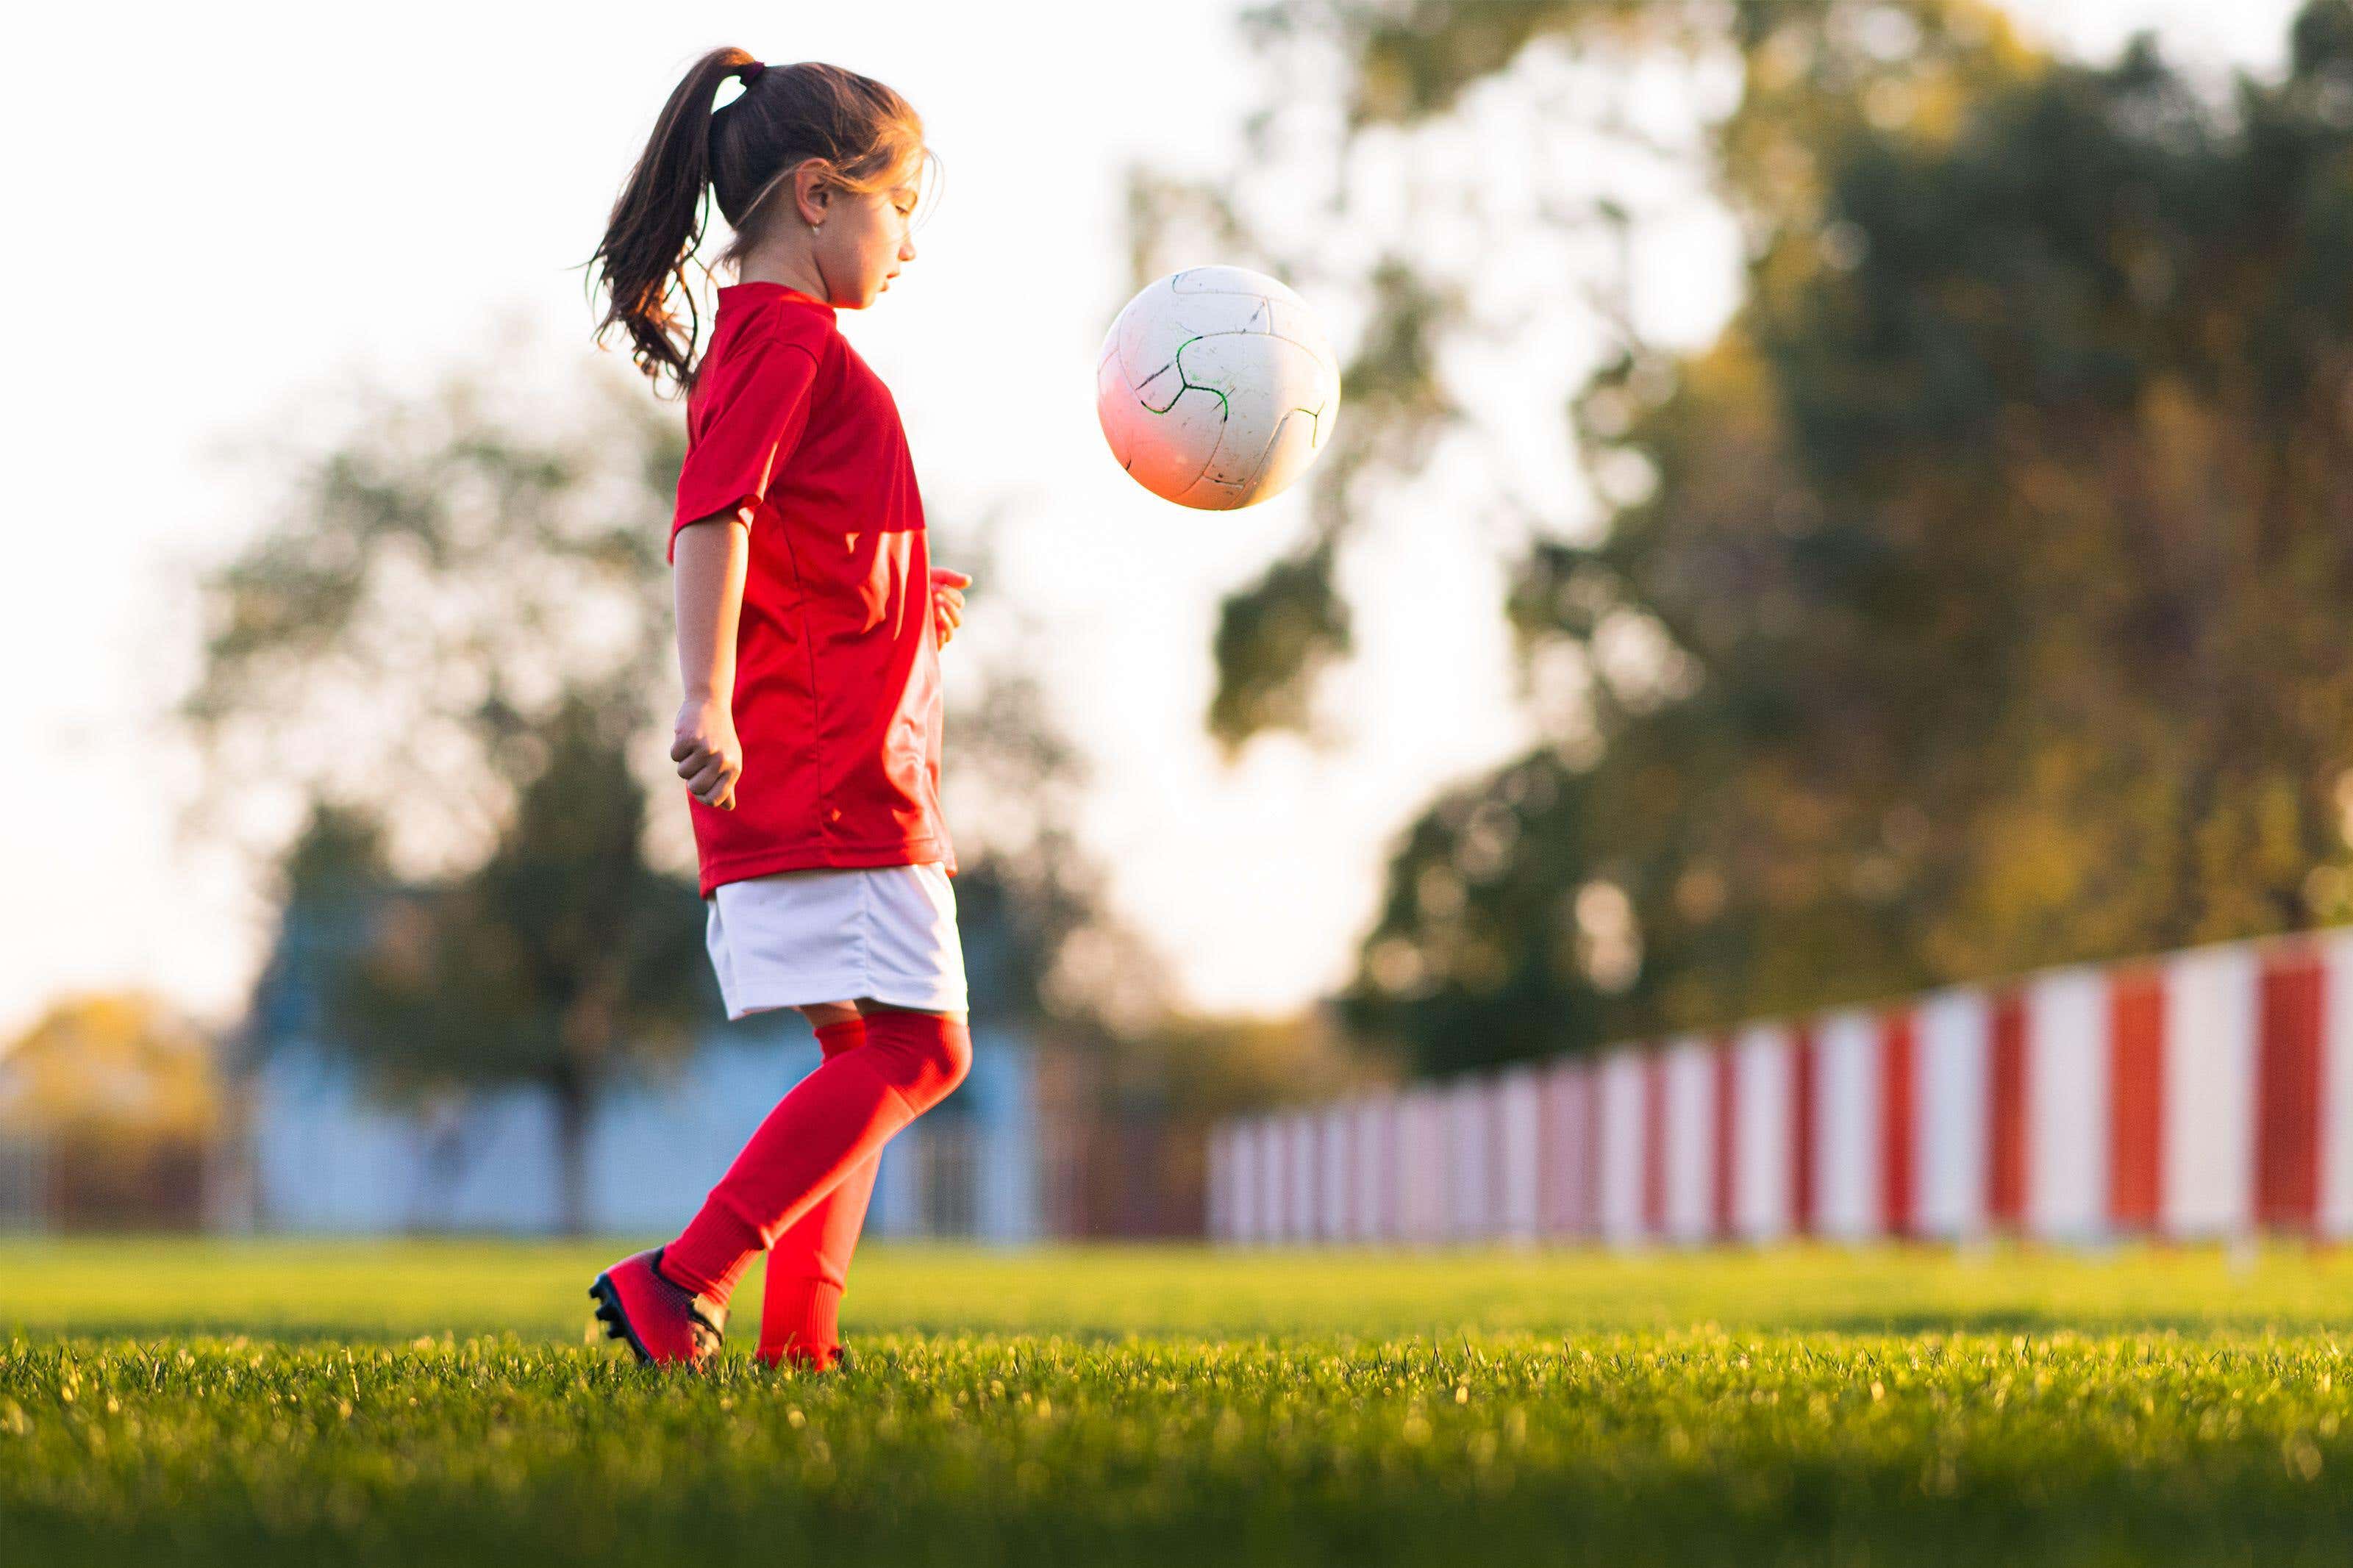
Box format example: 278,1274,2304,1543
1134,0,2353,1070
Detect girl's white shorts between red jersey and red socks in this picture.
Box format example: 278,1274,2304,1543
704,863,965,1018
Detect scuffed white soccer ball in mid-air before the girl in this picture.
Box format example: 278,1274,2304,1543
1094,265,1339,512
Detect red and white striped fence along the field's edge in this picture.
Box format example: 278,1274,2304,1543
1210,928,2353,1246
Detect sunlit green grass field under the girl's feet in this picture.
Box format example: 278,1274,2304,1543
13,1241,2353,1568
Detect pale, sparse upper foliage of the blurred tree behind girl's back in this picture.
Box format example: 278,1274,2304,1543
181,343,690,872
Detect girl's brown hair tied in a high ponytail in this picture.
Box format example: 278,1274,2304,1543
584,49,939,395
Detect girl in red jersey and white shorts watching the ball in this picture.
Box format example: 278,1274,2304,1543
588,49,972,1370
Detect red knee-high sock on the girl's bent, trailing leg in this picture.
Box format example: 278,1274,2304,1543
661,1009,972,1303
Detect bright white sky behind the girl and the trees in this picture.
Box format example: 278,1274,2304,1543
0,0,2294,1053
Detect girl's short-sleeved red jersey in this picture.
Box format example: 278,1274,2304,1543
668,282,955,898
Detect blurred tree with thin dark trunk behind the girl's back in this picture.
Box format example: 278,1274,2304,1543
184,362,715,1230
